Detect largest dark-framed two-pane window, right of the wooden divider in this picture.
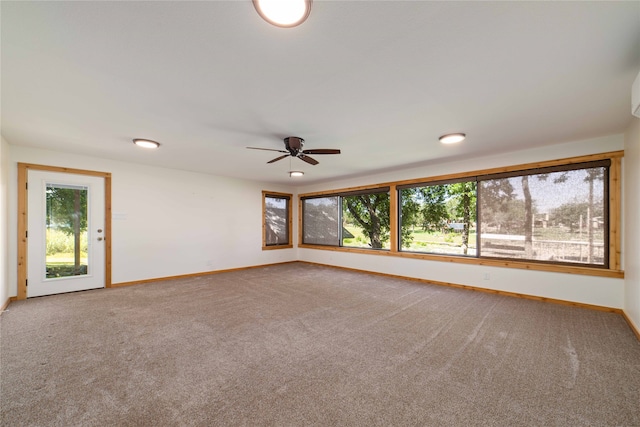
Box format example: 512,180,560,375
398,160,610,267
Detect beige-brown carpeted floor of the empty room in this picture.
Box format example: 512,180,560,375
0,263,640,426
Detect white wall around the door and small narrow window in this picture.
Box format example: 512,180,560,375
9,145,296,295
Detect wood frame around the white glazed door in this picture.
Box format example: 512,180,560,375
16,163,111,300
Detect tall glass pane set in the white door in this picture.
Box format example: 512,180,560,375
46,184,88,279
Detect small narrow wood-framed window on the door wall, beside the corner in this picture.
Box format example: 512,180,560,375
262,191,292,249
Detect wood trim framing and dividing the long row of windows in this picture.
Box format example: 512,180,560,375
298,150,624,278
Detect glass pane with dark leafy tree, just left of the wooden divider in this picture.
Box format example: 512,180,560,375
342,192,390,249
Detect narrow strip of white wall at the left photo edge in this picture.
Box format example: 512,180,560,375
0,137,9,306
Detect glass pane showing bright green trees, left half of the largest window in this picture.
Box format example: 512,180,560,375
400,181,477,255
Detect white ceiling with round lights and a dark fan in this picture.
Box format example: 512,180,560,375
0,0,640,184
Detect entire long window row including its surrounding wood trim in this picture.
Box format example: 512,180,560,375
300,151,623,277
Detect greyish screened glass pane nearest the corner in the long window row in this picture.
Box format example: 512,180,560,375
302,196,340,246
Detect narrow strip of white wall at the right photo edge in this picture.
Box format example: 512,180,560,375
623,119,640,331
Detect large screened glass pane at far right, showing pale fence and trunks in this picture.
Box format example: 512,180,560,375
479,167,608,266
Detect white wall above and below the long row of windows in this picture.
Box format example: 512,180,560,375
298,135,624,308
